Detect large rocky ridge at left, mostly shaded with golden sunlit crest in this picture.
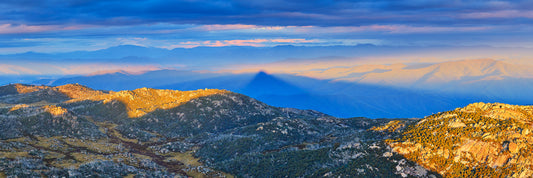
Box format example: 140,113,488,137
0,85,428,177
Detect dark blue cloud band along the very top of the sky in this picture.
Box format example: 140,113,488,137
0,0,532,29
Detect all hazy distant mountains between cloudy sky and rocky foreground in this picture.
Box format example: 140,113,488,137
0,48,533,118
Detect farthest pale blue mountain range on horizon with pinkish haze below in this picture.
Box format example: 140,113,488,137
0,44,531,77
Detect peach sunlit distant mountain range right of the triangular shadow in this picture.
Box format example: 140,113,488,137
297,59,533,104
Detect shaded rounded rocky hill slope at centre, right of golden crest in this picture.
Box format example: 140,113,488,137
118,93,327,140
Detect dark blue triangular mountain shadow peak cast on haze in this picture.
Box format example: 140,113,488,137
237,71,307,97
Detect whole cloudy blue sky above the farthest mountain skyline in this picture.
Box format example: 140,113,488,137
0,0,533,54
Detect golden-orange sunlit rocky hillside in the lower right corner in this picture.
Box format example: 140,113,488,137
382,103,533,177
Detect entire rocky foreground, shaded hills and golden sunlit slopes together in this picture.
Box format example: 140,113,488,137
0,84,533,177
